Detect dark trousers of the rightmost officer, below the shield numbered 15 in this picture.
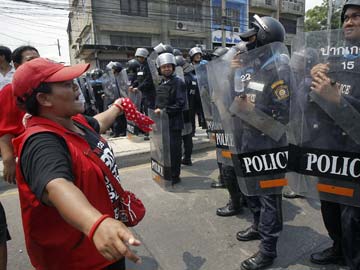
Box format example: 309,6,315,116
321,201,360,270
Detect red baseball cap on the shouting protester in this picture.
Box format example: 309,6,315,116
12,57,90,97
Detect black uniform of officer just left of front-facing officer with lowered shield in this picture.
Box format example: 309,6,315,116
134,61,156,115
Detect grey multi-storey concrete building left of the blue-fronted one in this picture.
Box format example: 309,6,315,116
68,0,211,68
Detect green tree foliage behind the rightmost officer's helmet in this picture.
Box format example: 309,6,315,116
305,0,341,31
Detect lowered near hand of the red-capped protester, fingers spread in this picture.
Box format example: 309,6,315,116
93,218,141,263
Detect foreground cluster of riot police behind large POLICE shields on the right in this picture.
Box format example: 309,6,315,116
148,5,360,269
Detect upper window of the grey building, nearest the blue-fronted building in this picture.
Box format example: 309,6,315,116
169,0,202,21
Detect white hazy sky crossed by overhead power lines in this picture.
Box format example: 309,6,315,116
0,0,323,63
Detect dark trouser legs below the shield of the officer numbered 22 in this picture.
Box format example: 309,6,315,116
246,194,283,258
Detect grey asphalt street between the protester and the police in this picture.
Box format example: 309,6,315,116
0,151,346,270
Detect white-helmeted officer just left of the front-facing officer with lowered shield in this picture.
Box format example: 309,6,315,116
129,48,156,140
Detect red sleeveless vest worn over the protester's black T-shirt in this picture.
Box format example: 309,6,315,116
13,115,114,270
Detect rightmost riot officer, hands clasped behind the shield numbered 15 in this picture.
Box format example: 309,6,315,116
309,0,360,270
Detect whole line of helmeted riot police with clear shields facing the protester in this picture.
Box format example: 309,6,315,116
71,0,360,269
